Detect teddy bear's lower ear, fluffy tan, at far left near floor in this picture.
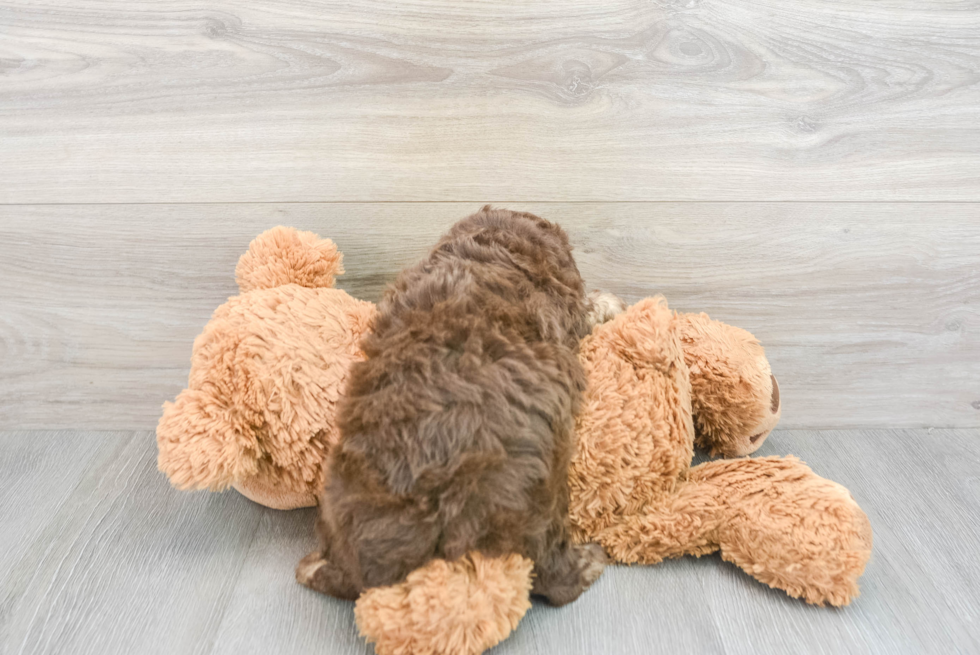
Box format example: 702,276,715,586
157,389,259,491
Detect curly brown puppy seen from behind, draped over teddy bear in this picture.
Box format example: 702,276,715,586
296,206,606,605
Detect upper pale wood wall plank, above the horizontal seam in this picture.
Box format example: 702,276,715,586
0,0,980,203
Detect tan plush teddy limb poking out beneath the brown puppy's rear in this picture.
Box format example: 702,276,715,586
354,552,534,655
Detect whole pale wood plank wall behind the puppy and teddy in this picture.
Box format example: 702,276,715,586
0,0,980,429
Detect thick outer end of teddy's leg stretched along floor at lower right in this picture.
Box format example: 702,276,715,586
690,457,872,606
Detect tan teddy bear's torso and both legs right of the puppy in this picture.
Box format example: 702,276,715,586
569,299,872,605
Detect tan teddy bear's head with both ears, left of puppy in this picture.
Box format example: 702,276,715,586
157,227,375,509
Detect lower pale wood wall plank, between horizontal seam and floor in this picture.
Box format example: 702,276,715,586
0,203,980,429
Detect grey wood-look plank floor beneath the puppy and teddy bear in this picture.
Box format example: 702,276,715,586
0,430,980,655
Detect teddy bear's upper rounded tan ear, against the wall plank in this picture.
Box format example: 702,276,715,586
235,225,344,293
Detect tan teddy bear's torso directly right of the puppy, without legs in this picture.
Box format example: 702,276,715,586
568,297,694,542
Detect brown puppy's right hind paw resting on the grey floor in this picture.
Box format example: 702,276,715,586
531,541,608,607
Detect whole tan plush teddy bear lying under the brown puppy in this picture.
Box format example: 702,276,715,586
157,228,871,655
